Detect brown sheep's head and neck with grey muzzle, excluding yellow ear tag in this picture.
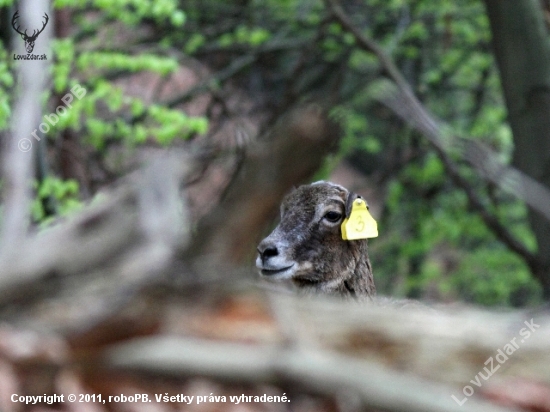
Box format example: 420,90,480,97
256,182,376,298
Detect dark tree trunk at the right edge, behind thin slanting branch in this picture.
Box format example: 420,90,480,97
485,0,550,300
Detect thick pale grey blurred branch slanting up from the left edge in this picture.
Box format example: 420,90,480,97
0,153,191,330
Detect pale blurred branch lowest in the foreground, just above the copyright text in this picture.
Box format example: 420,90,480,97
104,336,528,412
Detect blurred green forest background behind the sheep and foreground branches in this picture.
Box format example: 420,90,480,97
0,0,550,306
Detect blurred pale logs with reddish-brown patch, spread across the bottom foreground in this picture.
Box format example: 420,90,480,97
4,285,550,412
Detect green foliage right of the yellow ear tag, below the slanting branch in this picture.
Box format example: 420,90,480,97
371,154,540,306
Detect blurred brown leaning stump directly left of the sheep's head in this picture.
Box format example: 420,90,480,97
185,104,339,267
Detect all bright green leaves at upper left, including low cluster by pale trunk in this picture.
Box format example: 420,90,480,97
0,0,205,229
